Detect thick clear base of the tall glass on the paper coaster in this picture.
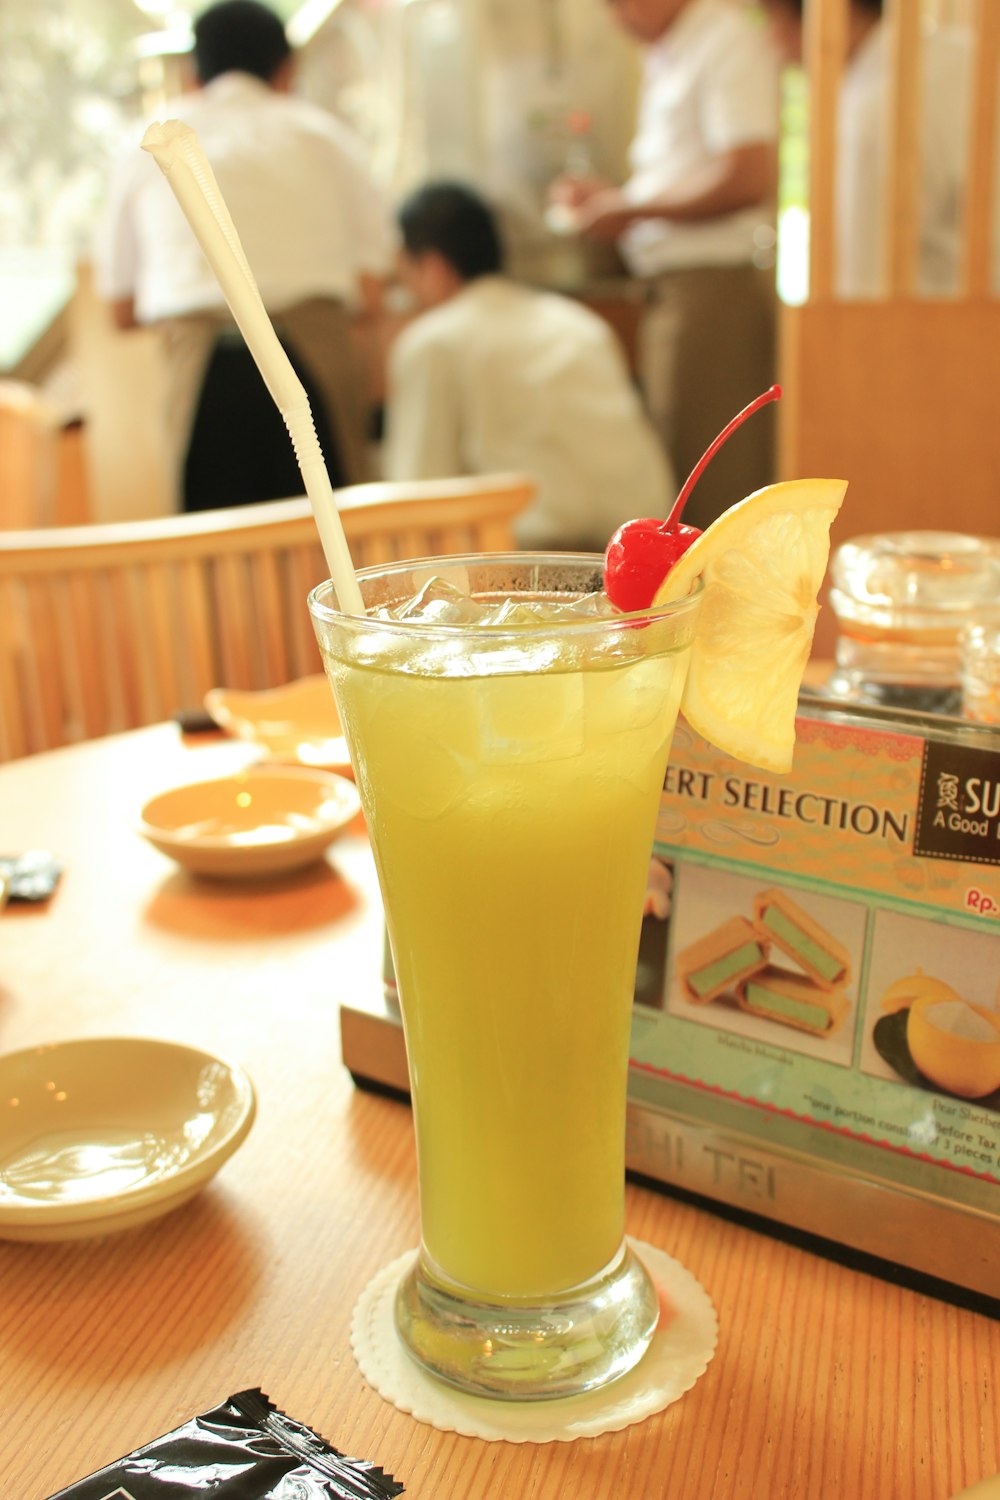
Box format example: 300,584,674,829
396,1245,660,1401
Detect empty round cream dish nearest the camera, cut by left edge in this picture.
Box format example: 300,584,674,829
0,1037,255,1241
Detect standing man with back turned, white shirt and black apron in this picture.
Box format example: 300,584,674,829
96,0,396,510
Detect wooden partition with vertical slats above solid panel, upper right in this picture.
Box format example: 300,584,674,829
778,0,1000,656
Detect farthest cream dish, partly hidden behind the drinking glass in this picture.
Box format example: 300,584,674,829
205,675,351,776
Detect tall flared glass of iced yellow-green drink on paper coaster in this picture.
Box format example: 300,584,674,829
309,554,699,1400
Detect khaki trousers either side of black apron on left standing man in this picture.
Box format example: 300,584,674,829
157,297,370,509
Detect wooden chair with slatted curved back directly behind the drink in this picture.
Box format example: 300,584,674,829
0,474,535,761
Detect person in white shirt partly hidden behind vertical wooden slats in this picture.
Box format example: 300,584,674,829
763,0,973,297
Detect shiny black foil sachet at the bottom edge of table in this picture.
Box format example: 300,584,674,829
49,1391,403,1500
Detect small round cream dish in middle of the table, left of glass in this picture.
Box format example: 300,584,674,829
138,765,361,879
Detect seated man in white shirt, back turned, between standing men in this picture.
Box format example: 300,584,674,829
385,183,675,552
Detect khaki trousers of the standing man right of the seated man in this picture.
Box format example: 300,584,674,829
639,266,777,528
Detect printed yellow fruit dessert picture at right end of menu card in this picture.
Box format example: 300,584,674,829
873,969,1000,1109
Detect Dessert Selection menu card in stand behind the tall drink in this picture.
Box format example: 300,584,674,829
342,693,1000,1298
